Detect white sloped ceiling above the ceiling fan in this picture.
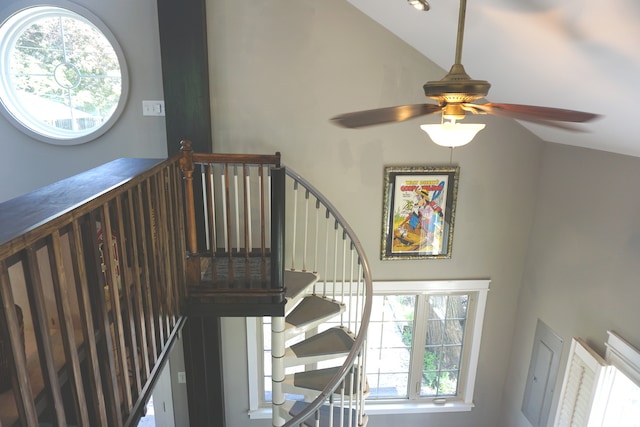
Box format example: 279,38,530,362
348,0,640,157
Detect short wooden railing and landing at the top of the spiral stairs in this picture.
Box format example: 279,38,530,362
180,141,285,316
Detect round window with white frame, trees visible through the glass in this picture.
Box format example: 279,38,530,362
0,3,129,145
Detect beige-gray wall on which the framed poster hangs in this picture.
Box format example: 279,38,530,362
207,0,542,427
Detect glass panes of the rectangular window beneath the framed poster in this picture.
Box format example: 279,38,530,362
367,293,470,401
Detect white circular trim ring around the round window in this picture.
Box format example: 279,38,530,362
0,0,129,145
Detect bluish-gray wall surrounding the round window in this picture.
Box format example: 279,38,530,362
0,0,167,202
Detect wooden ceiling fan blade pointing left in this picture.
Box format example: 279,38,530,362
331,104,442,129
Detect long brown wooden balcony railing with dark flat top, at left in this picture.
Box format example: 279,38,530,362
0,158,186,426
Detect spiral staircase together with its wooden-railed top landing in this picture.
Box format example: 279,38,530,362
182,142,371,427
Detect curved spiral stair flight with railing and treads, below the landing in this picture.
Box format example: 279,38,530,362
272,167,372,427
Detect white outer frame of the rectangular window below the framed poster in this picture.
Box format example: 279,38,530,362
246,279,491,419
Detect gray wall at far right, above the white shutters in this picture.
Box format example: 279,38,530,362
500,144,640,427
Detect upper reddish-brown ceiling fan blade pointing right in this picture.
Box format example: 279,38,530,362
465,103,600,123
